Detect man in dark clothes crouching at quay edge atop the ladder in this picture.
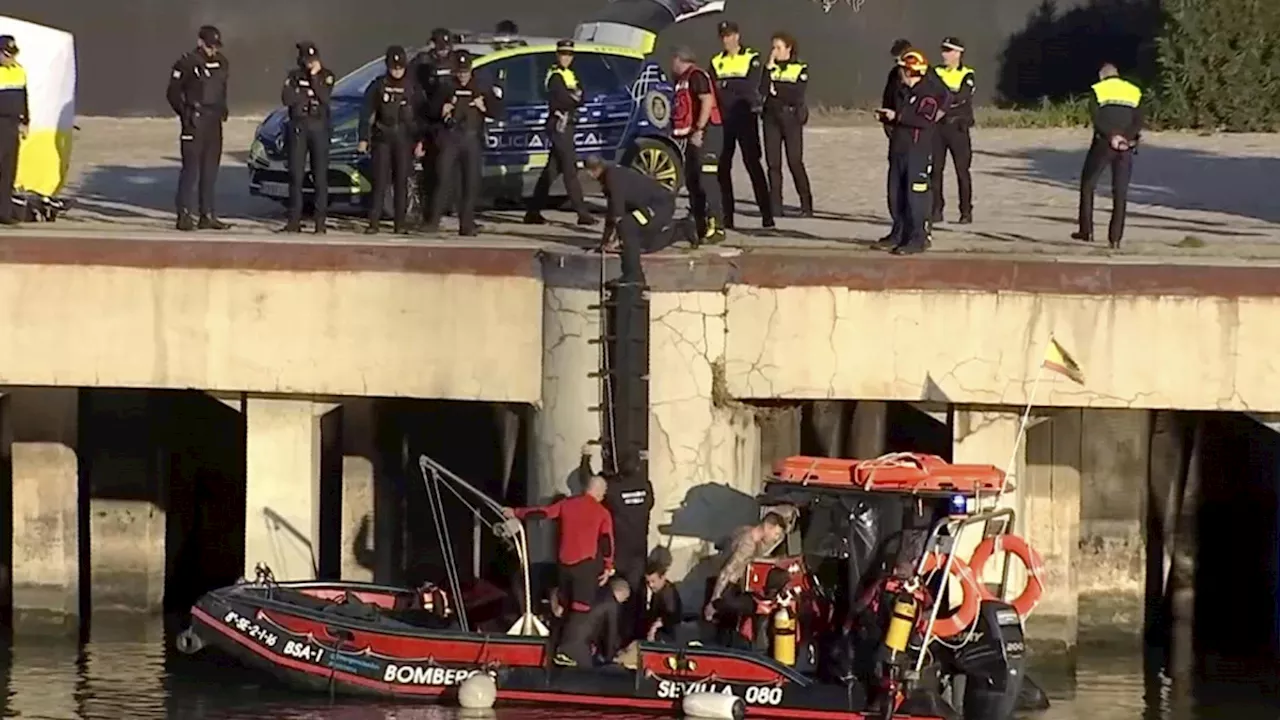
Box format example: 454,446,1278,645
582,155,690,279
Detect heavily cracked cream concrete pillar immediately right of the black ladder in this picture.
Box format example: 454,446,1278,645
649,292,762,607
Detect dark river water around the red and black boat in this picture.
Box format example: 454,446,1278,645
0,628,1280,720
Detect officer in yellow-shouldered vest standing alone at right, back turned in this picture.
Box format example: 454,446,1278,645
1071,63,1142,250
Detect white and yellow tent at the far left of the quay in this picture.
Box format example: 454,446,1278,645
0,15,76,197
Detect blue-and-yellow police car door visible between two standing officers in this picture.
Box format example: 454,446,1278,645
476,53,550,192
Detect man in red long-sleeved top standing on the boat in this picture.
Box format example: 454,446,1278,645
503,475,614,612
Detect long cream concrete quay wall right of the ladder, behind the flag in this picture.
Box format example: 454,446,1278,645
726,286,1280,410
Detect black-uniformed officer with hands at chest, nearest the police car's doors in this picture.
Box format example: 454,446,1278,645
425,50,503,236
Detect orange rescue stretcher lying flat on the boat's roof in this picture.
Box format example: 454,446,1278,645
772,452,1005,495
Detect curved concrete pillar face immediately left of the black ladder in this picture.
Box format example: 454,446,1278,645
527,287,602,562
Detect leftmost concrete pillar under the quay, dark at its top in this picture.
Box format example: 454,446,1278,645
6,388,81,633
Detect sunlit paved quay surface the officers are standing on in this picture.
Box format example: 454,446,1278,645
10,118,1280,265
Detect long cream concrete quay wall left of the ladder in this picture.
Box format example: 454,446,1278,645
0,265,543,404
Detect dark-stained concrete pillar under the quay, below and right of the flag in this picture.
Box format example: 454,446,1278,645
1079,410,1151,652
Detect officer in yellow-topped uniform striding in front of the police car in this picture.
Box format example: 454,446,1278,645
525,40,595,225
